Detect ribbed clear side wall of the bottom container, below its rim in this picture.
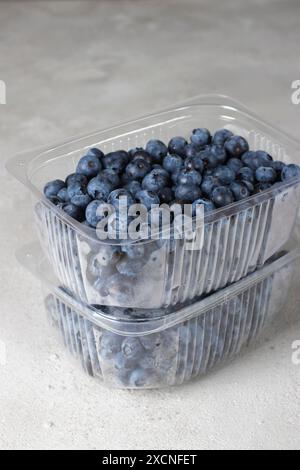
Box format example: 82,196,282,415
42,274,276,388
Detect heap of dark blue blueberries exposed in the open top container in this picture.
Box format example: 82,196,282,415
44,128,300,228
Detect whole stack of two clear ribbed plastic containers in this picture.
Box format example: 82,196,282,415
8,96,300,388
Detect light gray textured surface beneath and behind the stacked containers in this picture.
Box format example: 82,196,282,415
0,0,300,449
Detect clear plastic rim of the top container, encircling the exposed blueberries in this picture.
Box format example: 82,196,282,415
6,94,300,245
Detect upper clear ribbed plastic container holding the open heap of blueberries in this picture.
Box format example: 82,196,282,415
8,96,300,308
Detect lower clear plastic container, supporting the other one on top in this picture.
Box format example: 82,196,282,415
17,242,300,388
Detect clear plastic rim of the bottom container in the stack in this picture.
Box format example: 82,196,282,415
16,242,300,336
